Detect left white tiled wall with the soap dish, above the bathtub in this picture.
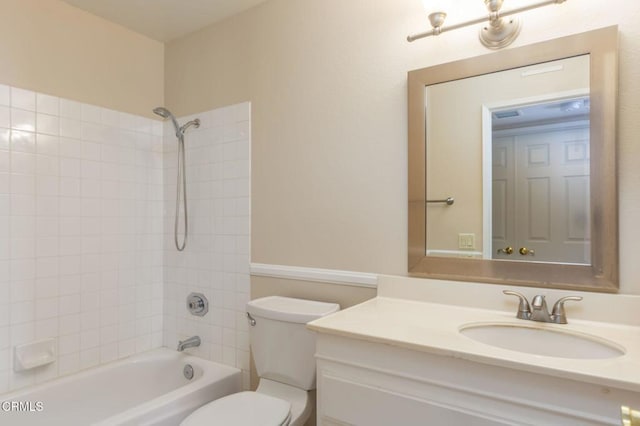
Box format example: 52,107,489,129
0,85,165,393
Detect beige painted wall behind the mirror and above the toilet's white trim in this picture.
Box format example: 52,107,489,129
165,0,640,294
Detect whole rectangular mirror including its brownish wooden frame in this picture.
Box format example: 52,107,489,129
409,27,618,291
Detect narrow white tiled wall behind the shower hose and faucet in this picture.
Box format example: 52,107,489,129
164,103,251,388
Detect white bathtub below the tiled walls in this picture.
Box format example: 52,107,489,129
0,349,242,426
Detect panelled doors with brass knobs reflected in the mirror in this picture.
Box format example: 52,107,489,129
493,127,590,264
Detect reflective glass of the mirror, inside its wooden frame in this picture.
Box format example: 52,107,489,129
425,55,590,264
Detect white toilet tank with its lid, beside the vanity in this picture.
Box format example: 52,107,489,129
247,296,340,390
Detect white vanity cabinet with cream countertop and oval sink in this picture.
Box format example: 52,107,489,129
308,277,640,426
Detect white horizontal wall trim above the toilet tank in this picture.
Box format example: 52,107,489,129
250,263,378,288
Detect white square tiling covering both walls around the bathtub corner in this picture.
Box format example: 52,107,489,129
0,85,251,392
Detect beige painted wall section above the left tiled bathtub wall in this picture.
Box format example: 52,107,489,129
0,0,164,116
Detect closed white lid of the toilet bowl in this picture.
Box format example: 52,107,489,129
180,392,291,426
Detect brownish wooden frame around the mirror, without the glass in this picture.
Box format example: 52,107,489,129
408,26,619,292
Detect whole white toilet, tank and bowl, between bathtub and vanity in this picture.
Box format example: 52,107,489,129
180,296,340,426
